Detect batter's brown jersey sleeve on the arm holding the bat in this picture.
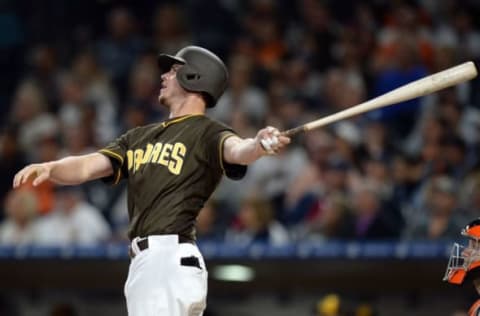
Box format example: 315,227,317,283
207,124,247,180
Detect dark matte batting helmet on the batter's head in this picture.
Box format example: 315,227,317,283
158,46,228,107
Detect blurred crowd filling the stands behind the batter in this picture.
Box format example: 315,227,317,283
0,0,480,245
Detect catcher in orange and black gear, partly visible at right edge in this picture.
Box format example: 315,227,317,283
443,218,480,316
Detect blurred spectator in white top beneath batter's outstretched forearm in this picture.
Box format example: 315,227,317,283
35,186,111,246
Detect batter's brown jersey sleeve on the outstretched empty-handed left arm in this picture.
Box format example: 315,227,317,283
98,133,128,184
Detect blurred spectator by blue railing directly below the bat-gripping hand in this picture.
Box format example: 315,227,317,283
225,197,289,246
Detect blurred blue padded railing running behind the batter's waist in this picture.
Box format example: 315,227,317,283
0,241,452,260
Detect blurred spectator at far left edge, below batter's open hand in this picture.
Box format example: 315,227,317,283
0,189,38,246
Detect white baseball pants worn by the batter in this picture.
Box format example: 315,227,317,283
125,235,208,316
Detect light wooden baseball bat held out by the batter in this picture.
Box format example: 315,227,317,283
282,61,477,136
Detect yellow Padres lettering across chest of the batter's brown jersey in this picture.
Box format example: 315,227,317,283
127,142,187,175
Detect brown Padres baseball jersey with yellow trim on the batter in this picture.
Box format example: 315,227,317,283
99,115,247,240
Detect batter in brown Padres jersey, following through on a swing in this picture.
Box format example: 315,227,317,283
13,46,290,316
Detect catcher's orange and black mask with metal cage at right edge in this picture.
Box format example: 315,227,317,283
443,218,480,284
